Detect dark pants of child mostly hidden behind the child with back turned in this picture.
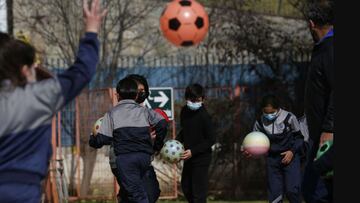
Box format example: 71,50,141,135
111,166,161,203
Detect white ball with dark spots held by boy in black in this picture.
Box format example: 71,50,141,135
160,140,185,163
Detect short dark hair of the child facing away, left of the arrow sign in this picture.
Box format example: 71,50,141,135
116,77,138,100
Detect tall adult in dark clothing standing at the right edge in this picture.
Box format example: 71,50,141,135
302,2,335,203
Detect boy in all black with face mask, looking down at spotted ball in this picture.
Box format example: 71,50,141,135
177,84,215,203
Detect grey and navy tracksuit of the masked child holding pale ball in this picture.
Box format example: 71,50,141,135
254,109,304,203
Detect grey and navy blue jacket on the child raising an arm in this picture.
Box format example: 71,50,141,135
0,33,99,184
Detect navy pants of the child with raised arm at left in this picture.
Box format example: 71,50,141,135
0,183,41,203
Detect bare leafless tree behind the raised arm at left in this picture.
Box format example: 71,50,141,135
11,0,160,195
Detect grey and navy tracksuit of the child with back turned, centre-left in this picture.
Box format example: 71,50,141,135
89,100,167,203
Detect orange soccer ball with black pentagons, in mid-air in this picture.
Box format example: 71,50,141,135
160,0,209,46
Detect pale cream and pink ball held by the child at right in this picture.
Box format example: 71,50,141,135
242,132,270,156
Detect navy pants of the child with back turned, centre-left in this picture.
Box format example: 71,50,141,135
116,152,151,203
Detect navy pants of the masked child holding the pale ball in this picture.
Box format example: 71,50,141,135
267,154,301,203
